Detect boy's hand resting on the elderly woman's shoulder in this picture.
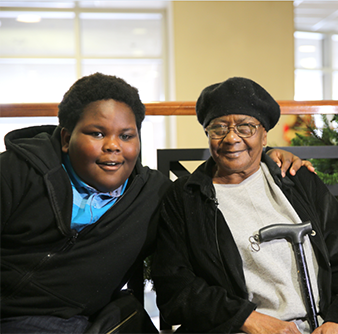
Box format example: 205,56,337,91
266,148,315,177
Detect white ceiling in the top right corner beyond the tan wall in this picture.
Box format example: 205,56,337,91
294,0,338,33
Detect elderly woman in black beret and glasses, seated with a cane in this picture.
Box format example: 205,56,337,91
153,77,338,334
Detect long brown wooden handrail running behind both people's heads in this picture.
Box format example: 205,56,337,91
0,100,338,117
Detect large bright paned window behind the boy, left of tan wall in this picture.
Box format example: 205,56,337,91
0,1,167,168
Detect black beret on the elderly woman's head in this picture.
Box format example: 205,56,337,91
196,77,280,131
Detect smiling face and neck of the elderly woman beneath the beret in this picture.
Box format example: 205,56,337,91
209,115,267,184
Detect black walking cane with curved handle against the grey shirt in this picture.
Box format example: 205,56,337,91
258,222,318,332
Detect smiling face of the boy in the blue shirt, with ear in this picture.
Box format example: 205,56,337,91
61,99,140,192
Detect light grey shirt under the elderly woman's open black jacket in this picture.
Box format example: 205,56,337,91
214,163,319,333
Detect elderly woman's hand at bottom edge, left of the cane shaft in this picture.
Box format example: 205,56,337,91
241,311,302,334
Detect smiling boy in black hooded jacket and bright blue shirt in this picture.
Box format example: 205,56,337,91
0,73,310,334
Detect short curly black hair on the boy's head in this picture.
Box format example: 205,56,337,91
58,73,145,133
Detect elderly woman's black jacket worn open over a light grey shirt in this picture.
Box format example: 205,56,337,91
152,153,338,334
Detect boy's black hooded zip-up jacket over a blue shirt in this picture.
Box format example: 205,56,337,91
0,126,170,318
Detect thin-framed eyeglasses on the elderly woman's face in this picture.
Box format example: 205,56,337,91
205,123,261,139
